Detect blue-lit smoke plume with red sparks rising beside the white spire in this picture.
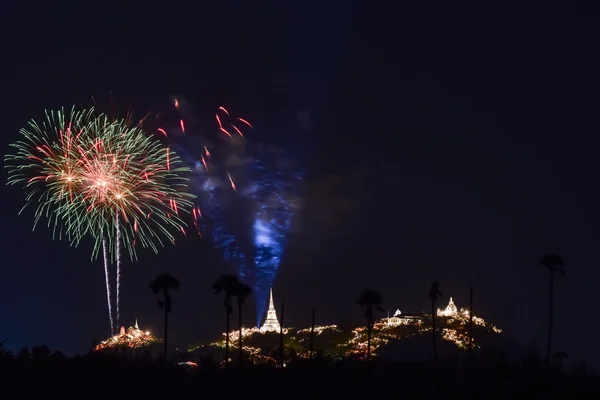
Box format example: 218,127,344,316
156,99,304,325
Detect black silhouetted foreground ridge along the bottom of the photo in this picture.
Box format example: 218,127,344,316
0,346,600,399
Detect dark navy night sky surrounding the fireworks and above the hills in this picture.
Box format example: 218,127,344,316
0,0,600,365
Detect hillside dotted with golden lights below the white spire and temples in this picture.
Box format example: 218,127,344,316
189,299,525,363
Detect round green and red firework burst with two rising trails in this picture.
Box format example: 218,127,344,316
5,109,195,329
